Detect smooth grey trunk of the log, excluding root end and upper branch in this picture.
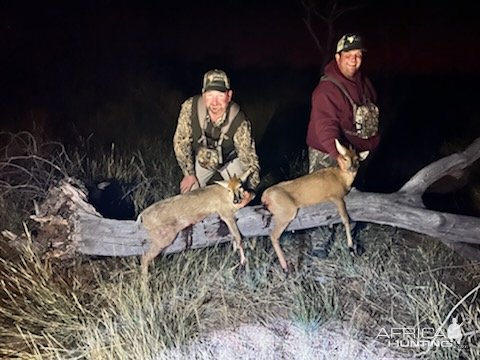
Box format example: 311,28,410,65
72,192,480,256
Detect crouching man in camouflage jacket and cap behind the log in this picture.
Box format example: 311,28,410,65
173,69,260,201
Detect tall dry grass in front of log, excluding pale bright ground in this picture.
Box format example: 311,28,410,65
0,226,480,359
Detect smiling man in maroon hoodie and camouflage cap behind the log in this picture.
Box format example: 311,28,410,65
305,34,380,257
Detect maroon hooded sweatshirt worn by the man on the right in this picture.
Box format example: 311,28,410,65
307,59,380,159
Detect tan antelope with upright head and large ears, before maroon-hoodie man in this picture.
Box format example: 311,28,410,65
262,139,369,272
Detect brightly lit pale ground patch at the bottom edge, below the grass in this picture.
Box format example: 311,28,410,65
155,320,408,360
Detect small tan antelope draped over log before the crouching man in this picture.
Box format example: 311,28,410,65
137,172,249,275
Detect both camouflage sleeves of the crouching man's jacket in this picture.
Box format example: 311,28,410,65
173,97,260,190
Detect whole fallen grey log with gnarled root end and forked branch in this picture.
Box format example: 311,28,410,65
4,138,480,259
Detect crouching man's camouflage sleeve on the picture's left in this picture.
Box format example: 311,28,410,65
173,98,195,176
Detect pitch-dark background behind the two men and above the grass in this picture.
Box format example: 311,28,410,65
0,0,480,212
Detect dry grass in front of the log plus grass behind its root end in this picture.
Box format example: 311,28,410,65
0,133,480,359
